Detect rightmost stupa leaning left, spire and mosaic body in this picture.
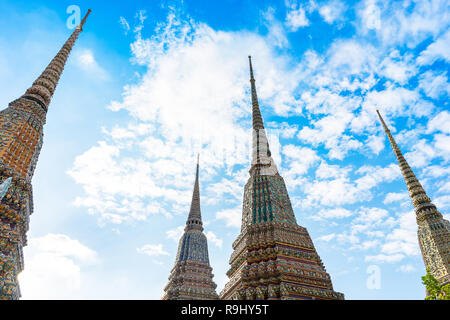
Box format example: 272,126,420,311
377,110,450,284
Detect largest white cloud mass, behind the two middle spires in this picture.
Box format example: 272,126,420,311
68,10,308,224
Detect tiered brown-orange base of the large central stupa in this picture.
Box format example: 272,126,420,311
220,223,344,300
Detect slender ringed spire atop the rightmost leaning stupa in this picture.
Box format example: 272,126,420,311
377,110,440,220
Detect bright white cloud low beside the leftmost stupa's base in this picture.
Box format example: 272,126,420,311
19,233,99,300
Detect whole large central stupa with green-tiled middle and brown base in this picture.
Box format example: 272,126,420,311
220,57,344,300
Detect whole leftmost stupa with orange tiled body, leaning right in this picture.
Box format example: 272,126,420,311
0,10,90,299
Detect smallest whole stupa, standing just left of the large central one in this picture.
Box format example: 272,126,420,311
162,160,219,300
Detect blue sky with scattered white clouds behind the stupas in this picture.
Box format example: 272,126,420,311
0,0,450,299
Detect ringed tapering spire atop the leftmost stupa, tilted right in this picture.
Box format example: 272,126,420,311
16,9,91,112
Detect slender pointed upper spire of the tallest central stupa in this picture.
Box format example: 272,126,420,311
248,56,278,175
